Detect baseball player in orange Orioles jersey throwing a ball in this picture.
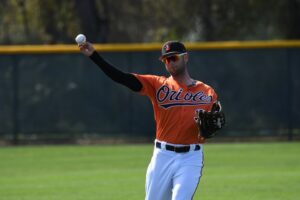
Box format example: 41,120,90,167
79,41,225,200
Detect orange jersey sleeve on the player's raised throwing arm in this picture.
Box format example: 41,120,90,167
133,74,159,97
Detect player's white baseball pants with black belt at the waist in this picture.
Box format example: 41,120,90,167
145,140,203,200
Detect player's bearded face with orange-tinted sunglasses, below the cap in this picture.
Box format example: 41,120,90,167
162,53,186,76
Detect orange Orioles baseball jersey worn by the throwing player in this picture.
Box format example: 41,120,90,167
134,74,217,144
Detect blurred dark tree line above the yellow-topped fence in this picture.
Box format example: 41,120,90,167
0,0,300,44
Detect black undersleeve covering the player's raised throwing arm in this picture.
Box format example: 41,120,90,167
90,51,142,92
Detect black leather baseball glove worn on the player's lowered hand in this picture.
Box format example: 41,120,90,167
195,101,225,139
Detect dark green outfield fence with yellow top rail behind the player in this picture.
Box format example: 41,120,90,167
0,41,300,142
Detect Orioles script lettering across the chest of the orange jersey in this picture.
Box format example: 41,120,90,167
156,85,212,108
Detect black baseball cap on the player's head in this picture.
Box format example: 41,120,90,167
159,41,186,59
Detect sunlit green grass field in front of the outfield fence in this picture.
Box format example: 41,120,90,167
0,143,300,200
